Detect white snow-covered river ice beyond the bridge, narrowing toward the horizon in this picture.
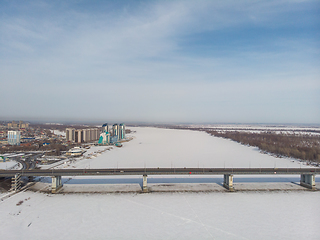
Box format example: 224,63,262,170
58,128,304,168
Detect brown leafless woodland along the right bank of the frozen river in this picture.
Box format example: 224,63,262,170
205,129,320,162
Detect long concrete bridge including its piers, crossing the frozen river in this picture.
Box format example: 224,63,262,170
0,168,320,193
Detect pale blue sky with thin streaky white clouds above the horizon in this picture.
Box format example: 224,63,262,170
0,0,320,124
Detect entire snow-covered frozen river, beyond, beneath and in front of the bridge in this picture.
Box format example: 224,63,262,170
0,128,320,239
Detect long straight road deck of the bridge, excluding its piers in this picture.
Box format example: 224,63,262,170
0,168,320,177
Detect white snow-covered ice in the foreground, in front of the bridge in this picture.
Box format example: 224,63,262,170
0,192,320,240
